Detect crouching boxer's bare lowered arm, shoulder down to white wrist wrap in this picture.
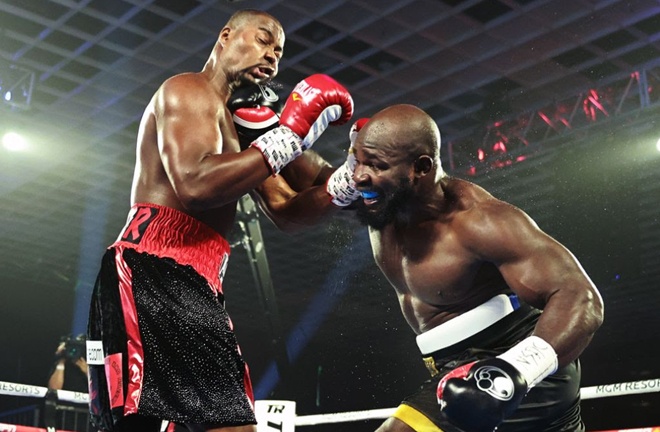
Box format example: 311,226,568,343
461,200,603,366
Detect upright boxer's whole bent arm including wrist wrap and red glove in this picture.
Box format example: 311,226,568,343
154,75,353,210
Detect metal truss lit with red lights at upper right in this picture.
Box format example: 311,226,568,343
446,66,660,175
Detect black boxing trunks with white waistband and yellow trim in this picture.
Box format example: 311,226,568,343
393,295,585,432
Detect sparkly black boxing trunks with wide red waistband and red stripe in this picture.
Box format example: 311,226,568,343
87,204,256,431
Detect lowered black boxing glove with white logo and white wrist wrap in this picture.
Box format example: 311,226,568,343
437,336,557,432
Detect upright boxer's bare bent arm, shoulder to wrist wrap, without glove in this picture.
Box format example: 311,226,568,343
154,76,271,210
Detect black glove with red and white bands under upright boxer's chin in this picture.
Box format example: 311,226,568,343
227,82,284,150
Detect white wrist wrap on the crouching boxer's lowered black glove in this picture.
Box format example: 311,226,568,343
498,336,558,389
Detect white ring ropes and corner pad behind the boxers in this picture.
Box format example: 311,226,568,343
0,378,660,432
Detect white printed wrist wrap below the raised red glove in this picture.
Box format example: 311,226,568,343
251,126,305,174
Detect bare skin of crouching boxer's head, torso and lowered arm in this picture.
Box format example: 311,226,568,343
354,105,603,366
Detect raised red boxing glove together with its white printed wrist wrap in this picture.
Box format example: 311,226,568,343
252,74,353,174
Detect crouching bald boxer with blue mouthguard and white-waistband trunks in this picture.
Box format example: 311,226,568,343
336,105,603,432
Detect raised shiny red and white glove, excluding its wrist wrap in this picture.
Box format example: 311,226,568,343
280,74,353,150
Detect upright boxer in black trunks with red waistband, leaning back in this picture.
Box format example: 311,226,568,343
87,10,353,432
